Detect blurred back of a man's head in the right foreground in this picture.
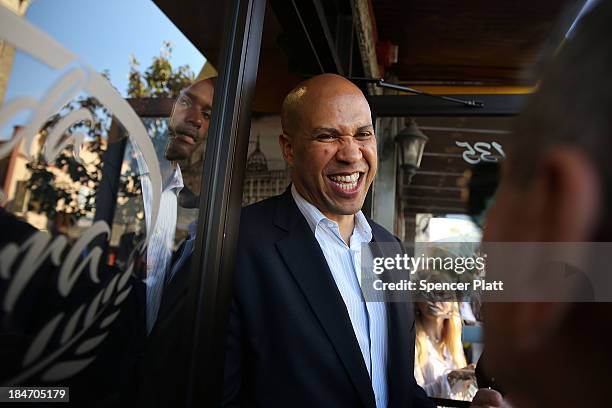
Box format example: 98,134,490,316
484,2,612,407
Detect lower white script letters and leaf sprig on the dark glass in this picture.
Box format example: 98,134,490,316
0,221,140,385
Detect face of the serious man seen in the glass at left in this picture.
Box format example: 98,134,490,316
166,79,214,162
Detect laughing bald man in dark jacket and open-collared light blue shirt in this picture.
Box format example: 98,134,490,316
224,74,500,408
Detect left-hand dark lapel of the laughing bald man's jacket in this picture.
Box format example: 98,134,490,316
276,190,376,407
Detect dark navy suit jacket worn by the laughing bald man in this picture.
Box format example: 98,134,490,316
224,189,433,408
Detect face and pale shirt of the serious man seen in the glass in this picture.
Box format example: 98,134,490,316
142,79,214,332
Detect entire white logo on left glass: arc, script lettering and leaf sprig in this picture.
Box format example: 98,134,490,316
0,6,161,386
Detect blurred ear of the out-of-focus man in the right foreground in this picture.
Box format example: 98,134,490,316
529,147,601,242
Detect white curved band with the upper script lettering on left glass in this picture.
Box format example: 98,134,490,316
0,7,161,241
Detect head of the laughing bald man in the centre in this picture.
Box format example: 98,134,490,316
279,74,377,219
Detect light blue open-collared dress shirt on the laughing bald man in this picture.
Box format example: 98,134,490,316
291,185,388,408
